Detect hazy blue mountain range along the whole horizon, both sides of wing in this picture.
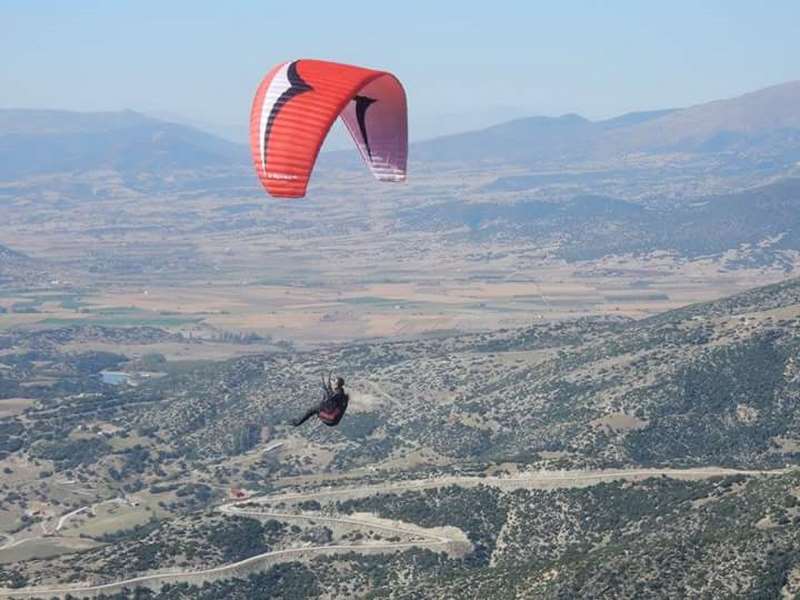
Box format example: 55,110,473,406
0,81,800,180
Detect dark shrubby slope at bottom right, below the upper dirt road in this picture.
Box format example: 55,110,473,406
326,473,800,599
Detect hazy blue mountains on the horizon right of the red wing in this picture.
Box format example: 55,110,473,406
411,81,800,165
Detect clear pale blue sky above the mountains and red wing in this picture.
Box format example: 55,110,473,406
0,0,800,141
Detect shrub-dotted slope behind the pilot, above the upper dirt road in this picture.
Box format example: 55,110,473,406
109,280,800,472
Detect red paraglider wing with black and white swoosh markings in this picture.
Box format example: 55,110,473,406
250,60,408,198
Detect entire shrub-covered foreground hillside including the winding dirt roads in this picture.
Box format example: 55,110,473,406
0,279,800,600
